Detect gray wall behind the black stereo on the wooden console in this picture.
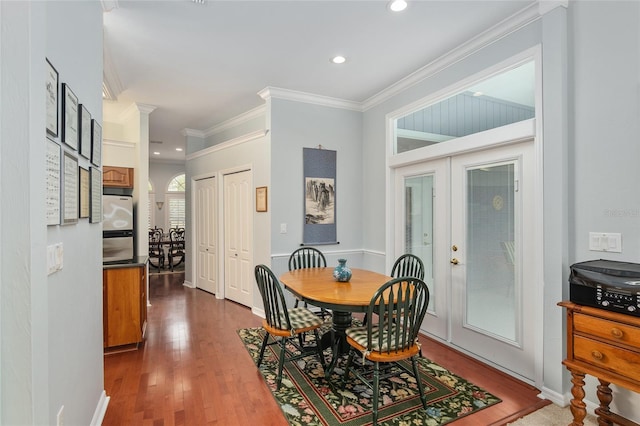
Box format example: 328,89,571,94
565,2,640,422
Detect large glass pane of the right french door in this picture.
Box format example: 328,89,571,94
465,163,517,341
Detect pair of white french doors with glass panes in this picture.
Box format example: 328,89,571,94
395,141,535,381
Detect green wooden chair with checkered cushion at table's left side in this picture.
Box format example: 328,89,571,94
255,265,325,389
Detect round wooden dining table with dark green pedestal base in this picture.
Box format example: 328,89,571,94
280,267,392,371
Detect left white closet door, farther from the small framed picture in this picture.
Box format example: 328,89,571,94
194,177,218,294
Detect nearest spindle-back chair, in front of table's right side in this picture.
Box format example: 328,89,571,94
342,277,429,426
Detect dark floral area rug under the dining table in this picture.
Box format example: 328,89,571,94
238,327,501,426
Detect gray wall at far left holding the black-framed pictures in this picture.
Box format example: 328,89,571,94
0,1,104,425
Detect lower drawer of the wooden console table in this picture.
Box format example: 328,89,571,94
573,335,640,377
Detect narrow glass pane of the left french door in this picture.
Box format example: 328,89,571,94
404,175,435,311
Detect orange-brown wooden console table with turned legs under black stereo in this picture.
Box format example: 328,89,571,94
558,302,640,426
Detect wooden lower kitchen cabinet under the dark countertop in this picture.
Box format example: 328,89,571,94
102,265,147,348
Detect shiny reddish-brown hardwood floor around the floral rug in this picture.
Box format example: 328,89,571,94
102,274,549,426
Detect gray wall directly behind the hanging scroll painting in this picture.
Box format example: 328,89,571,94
270,99,362,273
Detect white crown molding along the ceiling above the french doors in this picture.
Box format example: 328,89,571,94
362,2,541,111
